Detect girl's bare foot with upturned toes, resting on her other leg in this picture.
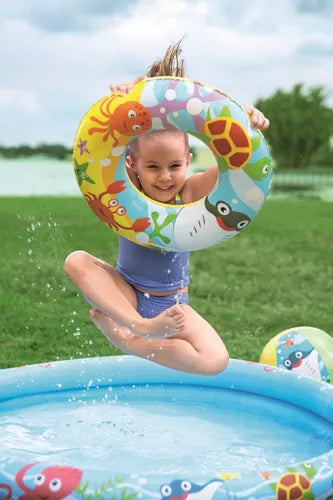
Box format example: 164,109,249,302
133,304,185,338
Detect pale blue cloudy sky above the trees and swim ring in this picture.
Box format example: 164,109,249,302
0,0,333,146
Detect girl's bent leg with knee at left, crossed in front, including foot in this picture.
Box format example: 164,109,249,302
65,251,184,336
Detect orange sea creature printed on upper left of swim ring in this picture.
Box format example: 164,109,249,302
88,95,152,147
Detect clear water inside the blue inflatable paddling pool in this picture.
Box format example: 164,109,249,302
0,384,333,480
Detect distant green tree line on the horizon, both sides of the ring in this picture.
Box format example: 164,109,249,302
0,83,333,170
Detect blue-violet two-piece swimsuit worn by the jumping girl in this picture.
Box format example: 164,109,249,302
116,237,190,318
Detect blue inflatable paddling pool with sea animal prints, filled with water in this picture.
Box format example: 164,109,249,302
0,356,333,500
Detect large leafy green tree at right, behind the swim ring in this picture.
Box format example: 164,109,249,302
255,83,333,169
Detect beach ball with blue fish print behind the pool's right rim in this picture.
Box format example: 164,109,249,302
260,326,333,383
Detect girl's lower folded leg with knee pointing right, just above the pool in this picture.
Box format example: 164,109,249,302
90,305,229,375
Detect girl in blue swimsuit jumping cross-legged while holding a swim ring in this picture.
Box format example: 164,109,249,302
65,42,269,375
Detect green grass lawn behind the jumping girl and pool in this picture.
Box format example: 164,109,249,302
0,197,333,368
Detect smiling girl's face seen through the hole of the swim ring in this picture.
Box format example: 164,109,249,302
126,132,192,203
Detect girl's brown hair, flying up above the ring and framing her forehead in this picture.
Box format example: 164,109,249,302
127,38,190,161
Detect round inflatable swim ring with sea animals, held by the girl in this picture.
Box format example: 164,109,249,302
73,77,272,251
